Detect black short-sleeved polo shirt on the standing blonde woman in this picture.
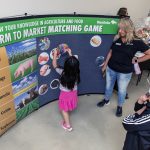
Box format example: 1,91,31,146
108,38,149,73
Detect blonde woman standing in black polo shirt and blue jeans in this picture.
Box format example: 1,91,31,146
97,18,150,117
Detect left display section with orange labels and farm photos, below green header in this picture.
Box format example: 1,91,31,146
0,39,39,134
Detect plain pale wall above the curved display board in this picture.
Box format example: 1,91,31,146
0,0,150,21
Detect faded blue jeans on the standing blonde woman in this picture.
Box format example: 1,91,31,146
104,67,132,106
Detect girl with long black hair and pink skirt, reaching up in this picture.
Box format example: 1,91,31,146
52,49,80,131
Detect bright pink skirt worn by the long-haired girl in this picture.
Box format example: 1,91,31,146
58,91,78,112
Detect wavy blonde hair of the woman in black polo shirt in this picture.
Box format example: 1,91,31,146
118,18,135,43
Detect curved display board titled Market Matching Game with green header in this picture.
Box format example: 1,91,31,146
0,15,118,135
